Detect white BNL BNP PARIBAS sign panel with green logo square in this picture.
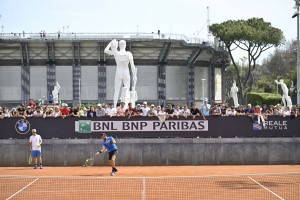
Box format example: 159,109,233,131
75,120,208,133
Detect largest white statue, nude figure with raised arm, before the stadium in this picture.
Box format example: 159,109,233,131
104,39,138,107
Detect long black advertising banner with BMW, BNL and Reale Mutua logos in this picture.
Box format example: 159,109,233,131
0,116,300,139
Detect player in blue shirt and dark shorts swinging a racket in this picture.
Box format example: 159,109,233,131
95,133,118,176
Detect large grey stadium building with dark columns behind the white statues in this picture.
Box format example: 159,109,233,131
0,33,230,106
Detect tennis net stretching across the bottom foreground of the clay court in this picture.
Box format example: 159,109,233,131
0,173,300,200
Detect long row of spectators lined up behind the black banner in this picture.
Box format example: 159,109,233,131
0,98,300,119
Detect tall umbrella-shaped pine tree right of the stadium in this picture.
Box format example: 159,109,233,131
209,18,284,97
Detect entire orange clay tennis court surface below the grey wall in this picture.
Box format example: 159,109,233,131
0,165,300,200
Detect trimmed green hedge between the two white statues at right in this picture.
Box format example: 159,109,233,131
247,92,282,106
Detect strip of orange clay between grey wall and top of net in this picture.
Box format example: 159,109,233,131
0,165,300,177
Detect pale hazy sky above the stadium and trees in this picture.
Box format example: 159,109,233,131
0,0,297,62
